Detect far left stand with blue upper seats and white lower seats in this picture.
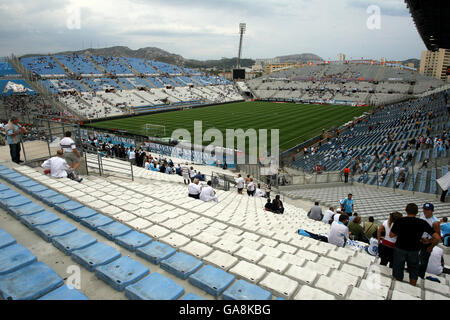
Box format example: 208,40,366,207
14,54,243,119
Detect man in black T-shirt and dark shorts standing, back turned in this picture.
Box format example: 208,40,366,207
389,203,441,286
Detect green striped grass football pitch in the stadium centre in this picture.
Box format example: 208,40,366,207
88,101,370,151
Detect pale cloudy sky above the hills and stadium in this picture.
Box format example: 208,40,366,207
0,0,425,60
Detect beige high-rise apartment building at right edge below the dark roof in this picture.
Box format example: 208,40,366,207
419,49,450,81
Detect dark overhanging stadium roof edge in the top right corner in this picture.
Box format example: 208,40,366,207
405,0,450,51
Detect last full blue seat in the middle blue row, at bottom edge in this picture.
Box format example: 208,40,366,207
125,272,184,300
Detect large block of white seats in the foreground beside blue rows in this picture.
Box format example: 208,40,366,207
7,162,446,299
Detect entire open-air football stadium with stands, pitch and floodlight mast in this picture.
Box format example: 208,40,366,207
0,0,450,301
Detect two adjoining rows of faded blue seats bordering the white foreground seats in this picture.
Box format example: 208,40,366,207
0,167,282,300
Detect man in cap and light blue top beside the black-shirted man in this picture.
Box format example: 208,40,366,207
419,202,441,279
